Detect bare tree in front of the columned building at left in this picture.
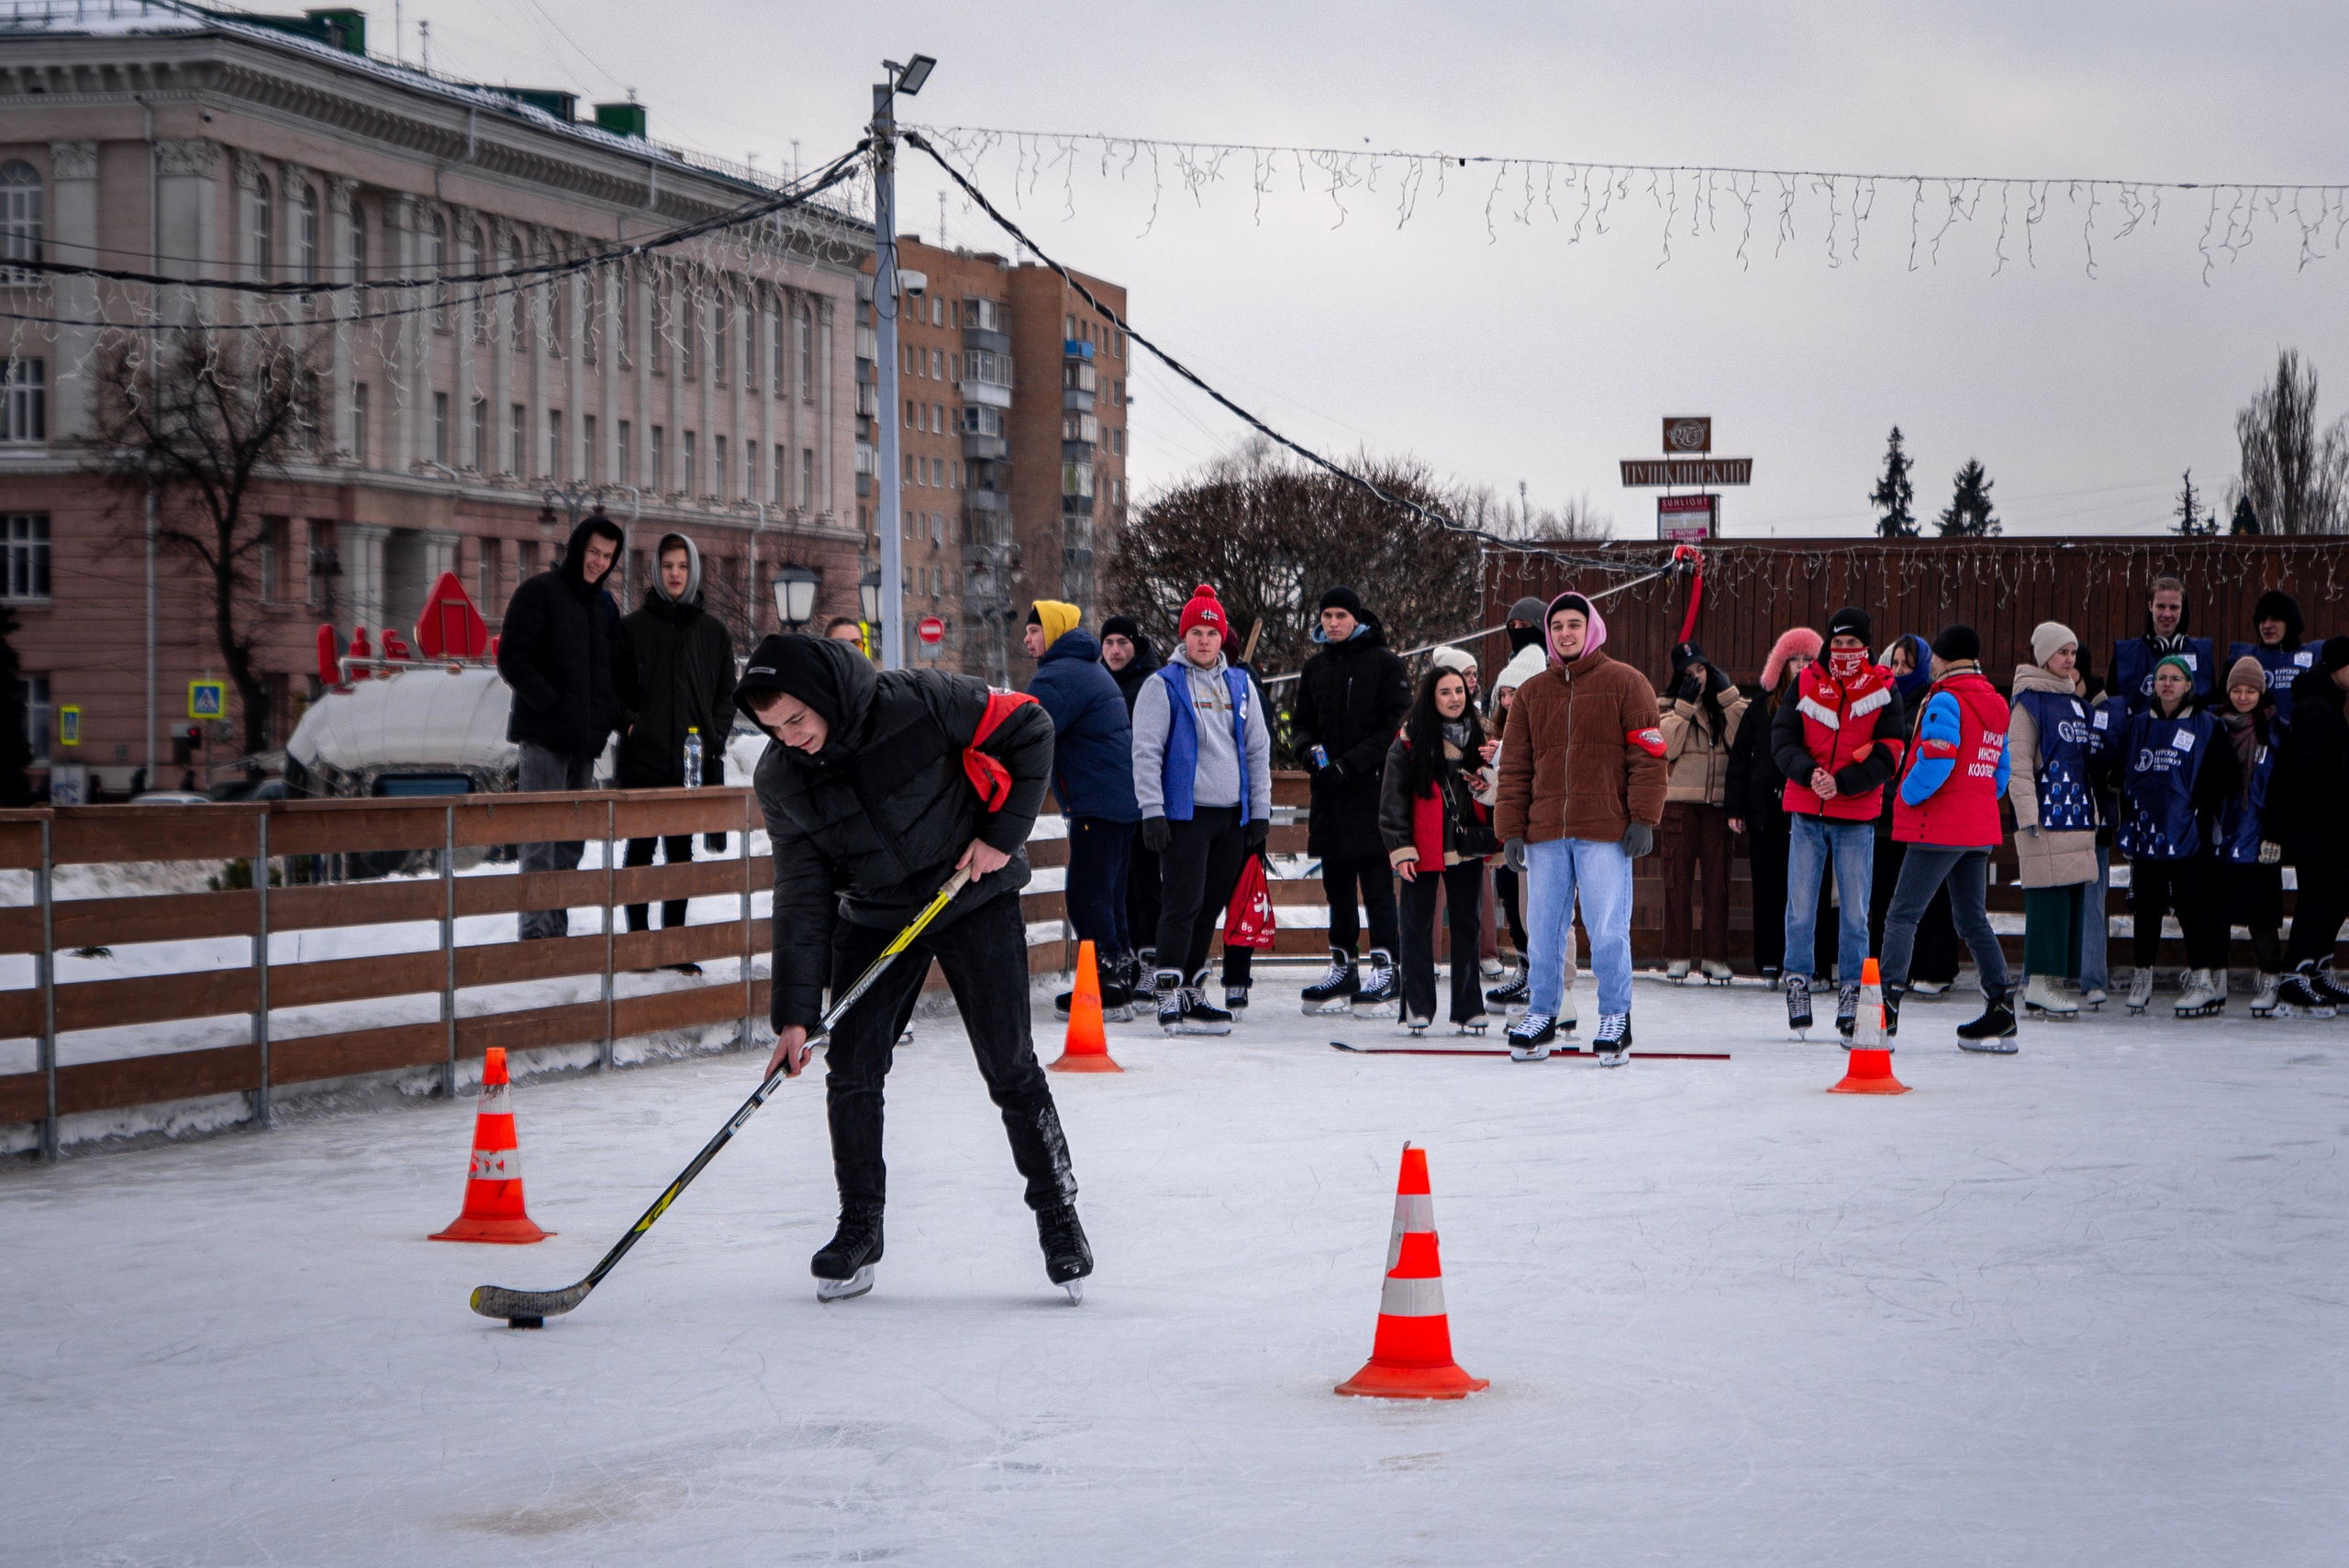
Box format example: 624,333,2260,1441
89,328,317,753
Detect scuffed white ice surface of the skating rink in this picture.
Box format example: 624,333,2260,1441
0,972,2349,1568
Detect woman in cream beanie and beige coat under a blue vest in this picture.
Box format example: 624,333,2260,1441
2006,619,2105,1018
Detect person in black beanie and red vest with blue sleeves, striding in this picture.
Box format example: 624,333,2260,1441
1884,627,2015,1054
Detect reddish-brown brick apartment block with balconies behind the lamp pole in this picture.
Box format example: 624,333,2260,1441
857,235,1130,685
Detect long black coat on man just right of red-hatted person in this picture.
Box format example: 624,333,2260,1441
1289,615,1412,859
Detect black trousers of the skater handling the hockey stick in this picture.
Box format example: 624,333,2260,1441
825,895,1075,1209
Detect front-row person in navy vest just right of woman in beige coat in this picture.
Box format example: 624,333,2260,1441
2117,652,2241,1018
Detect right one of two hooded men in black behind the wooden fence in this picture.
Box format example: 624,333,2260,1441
613,533,735,943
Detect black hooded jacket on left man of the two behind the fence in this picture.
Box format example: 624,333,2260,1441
498,517,637,756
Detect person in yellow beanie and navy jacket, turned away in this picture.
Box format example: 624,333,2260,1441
1024,598,1141,1023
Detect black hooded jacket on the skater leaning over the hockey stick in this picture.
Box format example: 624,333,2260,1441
735,636,1052,1029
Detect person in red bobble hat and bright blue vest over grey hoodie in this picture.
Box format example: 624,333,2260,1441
1134,582,1274,1035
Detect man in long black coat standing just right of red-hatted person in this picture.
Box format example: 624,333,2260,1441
1289,587,1412,1012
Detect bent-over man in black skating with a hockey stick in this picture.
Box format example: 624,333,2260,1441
735,636,1092,1300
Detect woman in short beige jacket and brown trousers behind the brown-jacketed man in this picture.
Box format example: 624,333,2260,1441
1656,643,1745,986
